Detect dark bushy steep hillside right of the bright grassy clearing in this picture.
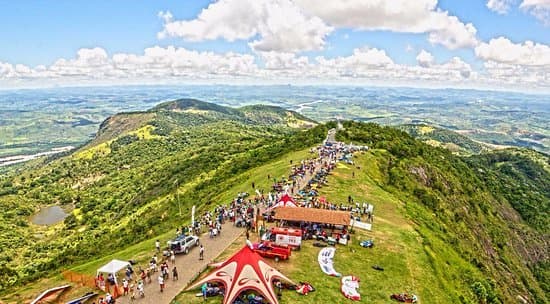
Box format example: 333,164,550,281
337,122,550,303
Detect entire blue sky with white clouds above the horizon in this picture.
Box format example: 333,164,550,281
0,0,550,92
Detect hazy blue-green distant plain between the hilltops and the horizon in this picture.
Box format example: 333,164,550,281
0,85,550,157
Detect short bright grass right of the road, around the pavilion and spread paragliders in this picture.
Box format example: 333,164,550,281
174,151,462,304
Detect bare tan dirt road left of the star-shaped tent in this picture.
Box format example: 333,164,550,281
117,221,244,304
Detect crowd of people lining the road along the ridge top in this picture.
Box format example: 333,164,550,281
92,137,370,304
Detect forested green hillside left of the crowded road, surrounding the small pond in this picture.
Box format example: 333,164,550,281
0,100,327,292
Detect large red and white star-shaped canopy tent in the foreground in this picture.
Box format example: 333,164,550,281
187,242,294,304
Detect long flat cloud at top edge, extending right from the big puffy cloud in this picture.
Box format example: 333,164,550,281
295,0,478,49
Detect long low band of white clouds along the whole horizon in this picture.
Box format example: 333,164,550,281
0,42,550,90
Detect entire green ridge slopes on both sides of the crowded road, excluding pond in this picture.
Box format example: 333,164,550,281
0,108,550,303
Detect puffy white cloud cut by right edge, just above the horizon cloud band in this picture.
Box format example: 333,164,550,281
475,37,550,65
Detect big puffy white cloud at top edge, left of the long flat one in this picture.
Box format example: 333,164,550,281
158,0,333,52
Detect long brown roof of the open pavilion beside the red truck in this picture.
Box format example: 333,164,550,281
273,207,351,226
